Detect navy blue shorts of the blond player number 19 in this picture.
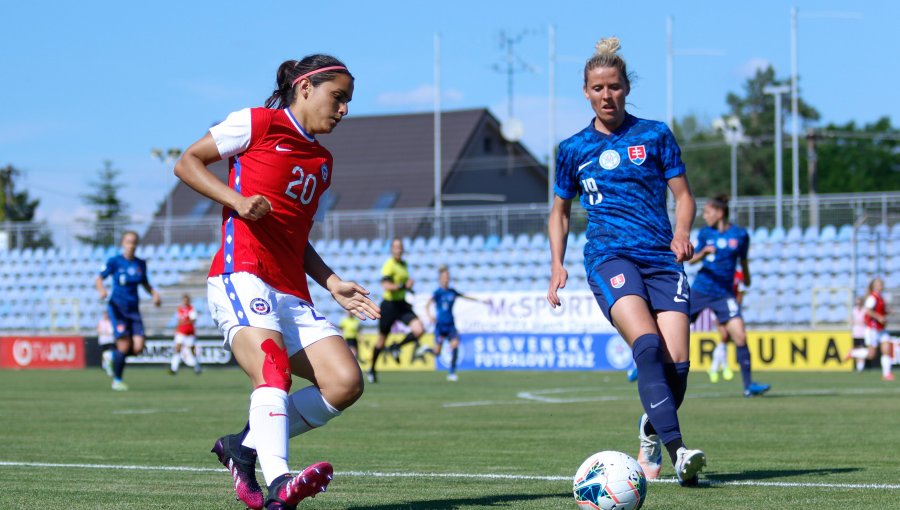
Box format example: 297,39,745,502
588,257,690,322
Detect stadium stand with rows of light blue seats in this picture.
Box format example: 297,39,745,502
0,223,900,334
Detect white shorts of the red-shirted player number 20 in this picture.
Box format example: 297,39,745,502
206,273,341,356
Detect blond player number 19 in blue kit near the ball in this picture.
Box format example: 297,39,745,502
547,37,706,485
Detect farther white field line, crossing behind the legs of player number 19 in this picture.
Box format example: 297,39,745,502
441,387,900,408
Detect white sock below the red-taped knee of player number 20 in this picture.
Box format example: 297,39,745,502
244,386,290,485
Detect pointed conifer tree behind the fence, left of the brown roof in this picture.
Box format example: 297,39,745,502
78,160,129,246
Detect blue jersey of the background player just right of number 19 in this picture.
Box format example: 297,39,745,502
691,225,750,297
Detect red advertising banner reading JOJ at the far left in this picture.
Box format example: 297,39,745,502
0,336,84,369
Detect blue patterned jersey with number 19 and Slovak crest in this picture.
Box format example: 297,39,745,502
555,113,685,274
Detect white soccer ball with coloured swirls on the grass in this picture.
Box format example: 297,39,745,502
572,451,647,510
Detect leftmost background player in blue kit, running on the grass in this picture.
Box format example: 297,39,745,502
94,230,162,391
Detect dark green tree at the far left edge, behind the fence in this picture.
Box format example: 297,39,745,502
0,165,53,248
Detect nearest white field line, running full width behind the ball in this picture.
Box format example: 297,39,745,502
0,461,900,490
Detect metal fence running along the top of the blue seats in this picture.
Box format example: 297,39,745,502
7,192,900,250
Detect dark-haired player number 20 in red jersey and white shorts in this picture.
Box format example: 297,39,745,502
175,55,380,510
